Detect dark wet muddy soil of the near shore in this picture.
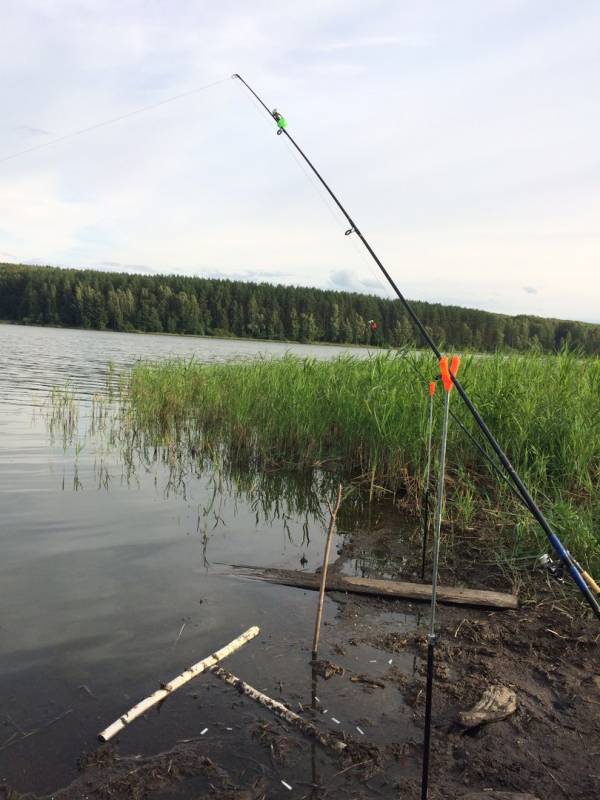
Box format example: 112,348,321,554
0,524,600,800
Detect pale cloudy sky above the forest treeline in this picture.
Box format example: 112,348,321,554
0,0,600,322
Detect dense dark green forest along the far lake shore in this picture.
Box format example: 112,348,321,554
0,264,600,355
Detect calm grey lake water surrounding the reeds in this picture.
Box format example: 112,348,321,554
0,325,420,792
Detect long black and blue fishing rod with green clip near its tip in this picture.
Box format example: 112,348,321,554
232,73,600,619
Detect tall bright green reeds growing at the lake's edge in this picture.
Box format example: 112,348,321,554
126,352,600,566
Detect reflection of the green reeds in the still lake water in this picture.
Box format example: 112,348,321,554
45,378,404,564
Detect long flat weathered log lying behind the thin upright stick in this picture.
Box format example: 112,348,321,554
232,564,519,608
